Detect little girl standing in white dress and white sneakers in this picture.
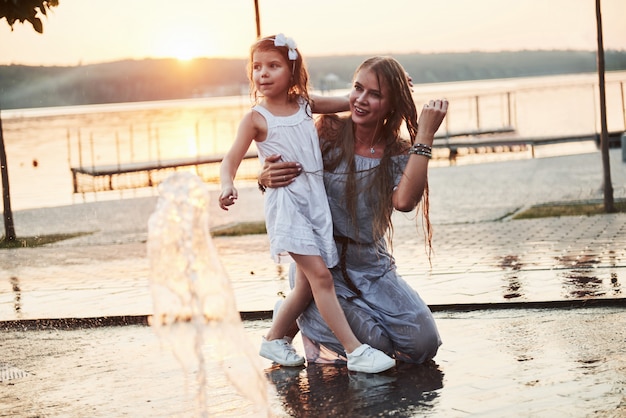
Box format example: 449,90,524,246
219,34,395,373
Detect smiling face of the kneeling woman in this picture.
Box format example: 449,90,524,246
349,68,391,127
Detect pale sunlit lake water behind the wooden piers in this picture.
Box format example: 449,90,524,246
2,71,626,210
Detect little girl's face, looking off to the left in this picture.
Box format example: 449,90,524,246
251,51,291,98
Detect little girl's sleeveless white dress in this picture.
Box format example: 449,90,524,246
252,100,339,267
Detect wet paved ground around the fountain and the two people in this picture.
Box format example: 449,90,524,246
0,150,626,417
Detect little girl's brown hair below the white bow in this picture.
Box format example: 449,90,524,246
248,36,311,108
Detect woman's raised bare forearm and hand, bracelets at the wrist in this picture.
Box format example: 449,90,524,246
392,99,448,212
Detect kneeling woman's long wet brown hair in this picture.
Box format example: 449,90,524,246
318,57,432,258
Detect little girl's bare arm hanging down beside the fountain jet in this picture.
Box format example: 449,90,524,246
220,112,259,210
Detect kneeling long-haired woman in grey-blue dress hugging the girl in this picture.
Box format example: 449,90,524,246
259,57,448,363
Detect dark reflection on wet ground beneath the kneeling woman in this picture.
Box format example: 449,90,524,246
265,362,443,417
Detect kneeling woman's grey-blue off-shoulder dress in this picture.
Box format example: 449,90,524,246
291,155,441,363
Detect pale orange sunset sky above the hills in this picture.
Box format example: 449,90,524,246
0,0,626,65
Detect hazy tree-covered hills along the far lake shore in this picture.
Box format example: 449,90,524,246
0,51,626,109
